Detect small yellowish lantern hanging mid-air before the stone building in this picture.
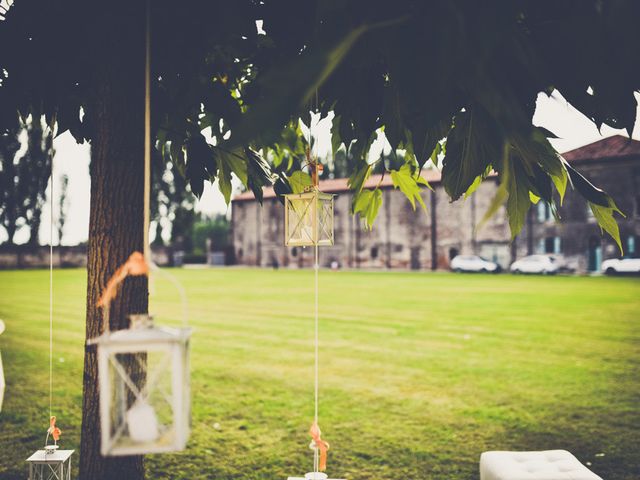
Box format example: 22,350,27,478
284,188,334,247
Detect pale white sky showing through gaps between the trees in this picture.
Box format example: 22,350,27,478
8,92,640,245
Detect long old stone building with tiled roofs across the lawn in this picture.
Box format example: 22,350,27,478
232,136,640,271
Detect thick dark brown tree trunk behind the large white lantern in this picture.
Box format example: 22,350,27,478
80,2,148,480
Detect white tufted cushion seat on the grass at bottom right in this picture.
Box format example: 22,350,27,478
480,450,602,480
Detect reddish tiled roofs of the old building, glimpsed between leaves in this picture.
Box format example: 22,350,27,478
233,135,640,201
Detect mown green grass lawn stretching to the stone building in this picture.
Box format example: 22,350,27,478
0,269,640,480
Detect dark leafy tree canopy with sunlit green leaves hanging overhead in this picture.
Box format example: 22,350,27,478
0,0,640,248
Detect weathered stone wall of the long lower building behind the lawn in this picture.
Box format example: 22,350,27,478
232,181,509,270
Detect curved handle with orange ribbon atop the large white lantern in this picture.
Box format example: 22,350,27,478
97,252,189,332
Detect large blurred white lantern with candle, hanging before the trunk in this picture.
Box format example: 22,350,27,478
91,314,191,456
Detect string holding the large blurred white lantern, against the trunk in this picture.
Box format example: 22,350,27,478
143,0,151,265
